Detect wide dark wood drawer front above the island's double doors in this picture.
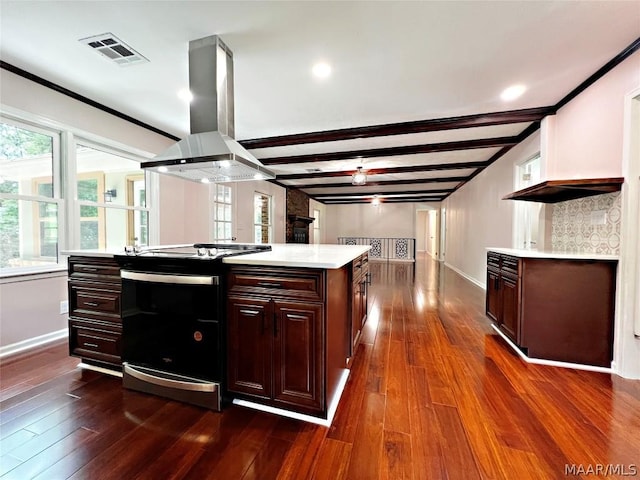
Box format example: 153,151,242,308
229,268,324,300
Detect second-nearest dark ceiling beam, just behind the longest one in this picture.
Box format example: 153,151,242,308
258,136,518,166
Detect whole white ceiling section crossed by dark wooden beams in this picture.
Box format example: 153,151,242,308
245,107,555,204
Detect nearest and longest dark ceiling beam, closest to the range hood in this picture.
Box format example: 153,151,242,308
240,107,555,149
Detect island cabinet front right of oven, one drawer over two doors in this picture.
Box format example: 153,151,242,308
227,267,328,415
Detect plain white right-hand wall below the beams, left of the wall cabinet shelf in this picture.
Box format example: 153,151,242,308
443,132,540,286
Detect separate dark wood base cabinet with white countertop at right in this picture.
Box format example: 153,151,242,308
486,248,617,369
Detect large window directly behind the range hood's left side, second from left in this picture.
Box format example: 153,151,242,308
76,141,149,250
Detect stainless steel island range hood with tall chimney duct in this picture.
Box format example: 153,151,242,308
141,35,275,183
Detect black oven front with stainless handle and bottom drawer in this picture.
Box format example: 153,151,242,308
121,269,224,408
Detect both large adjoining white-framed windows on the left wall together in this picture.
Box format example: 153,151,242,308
0,109,155,275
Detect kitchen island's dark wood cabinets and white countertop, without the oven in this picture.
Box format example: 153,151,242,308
64,244,370,424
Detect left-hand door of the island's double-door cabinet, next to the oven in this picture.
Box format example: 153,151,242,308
227,297,273,398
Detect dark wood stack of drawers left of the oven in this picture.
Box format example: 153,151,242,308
68,256,122,370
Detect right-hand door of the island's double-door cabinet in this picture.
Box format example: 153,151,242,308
272,301,324,410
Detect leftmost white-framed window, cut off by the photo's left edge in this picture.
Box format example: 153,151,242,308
0,118,63,270
